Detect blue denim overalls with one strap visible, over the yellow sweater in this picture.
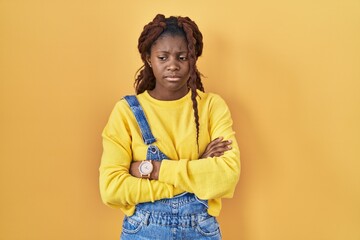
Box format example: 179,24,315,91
121,96,221,240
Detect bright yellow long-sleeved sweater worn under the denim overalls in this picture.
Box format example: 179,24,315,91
99,91,240,216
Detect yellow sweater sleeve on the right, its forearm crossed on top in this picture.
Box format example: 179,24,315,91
159,95,240,199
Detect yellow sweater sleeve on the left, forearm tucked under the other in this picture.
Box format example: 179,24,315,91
99,102,183,209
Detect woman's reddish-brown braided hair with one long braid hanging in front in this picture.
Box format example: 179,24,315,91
134,14,204,150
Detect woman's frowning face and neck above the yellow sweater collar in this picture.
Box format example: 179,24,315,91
147,35,190,100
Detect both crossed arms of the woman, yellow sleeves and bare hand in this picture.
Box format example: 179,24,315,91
99,95,240,210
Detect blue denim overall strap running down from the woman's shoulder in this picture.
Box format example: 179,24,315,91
124,95,156,145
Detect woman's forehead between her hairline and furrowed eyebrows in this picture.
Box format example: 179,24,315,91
151,34,187,52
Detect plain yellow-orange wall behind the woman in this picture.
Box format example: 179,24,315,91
0,0,360,240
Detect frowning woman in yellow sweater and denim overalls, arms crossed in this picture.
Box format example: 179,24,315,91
100,14,240,240
